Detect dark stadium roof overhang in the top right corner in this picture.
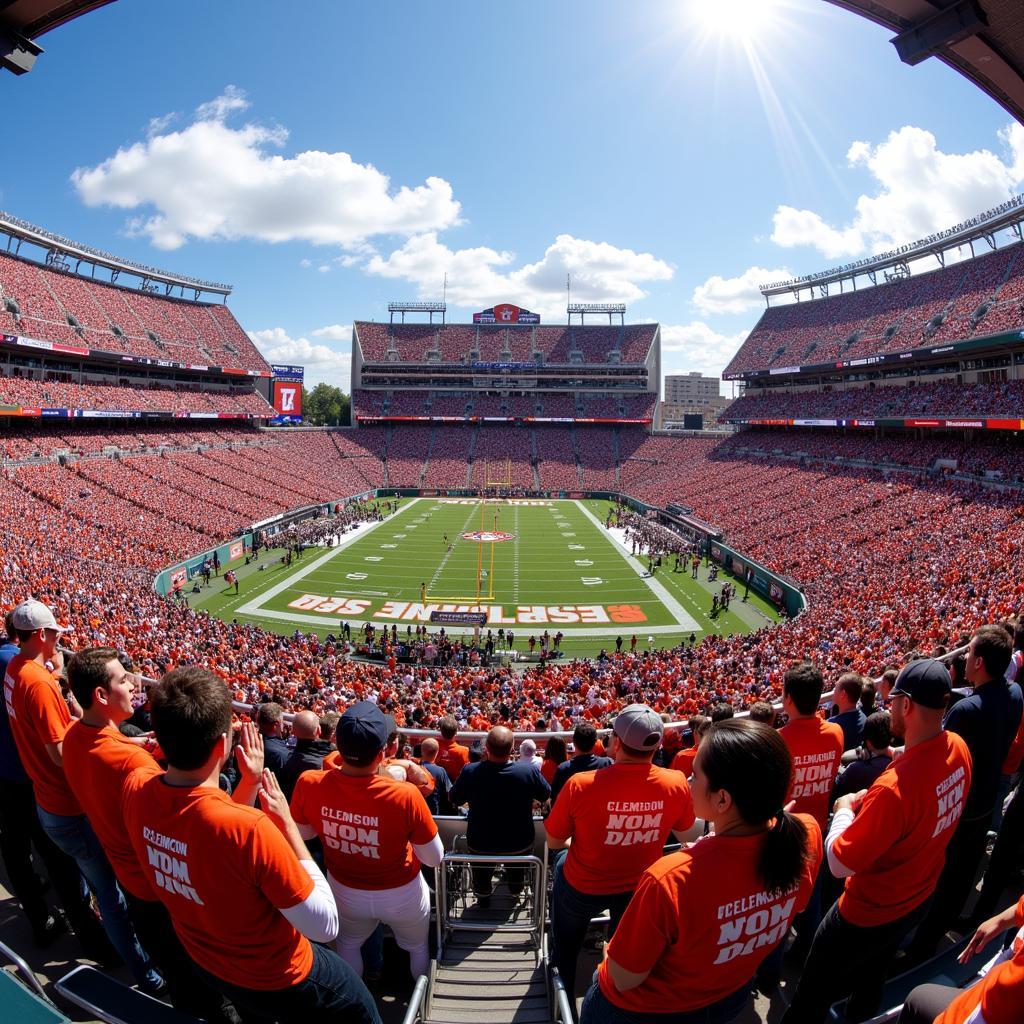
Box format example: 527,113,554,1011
828,0,1024,123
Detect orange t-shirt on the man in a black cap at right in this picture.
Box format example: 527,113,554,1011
833,732,971,928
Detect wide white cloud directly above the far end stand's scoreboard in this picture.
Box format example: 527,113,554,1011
366,231,673,316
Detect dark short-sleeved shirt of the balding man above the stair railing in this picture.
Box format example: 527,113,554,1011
452,761,551,853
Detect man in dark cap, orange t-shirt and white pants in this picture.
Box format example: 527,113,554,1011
291,700,444,978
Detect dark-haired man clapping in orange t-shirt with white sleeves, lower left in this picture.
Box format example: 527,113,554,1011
122,667,380,1024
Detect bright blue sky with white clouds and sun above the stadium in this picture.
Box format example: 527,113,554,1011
0,0,1024,389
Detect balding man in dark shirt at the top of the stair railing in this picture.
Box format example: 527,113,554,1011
452,725,551,907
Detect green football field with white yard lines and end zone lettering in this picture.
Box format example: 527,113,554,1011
194,498,777,656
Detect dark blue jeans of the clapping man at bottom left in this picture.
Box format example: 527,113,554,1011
200,942,381,1024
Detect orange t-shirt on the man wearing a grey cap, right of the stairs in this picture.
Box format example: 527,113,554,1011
544,764,695,896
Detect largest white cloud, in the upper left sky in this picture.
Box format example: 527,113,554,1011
72,86,460,250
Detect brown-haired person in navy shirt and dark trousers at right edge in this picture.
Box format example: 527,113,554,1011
910,626,1024,963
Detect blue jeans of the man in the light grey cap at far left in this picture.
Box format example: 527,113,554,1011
36,804,161,986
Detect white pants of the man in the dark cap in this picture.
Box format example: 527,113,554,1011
327,871,430,978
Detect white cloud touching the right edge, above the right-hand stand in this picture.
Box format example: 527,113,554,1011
772,122,1024,259
